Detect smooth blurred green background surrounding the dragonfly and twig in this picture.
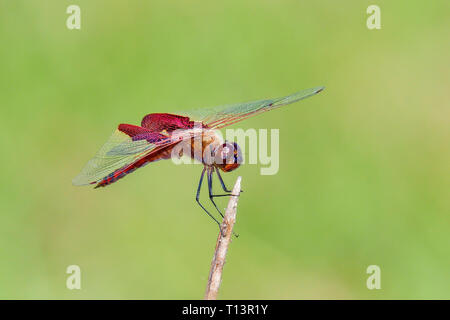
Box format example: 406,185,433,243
0,0,450,299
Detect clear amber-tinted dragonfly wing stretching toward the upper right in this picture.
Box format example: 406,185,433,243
178,87,325,129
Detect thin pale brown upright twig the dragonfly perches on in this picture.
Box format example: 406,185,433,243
205,177,241,300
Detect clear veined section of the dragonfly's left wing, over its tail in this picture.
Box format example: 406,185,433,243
72,130,173,185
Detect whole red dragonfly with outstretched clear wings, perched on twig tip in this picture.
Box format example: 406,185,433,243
73,87,324,228
